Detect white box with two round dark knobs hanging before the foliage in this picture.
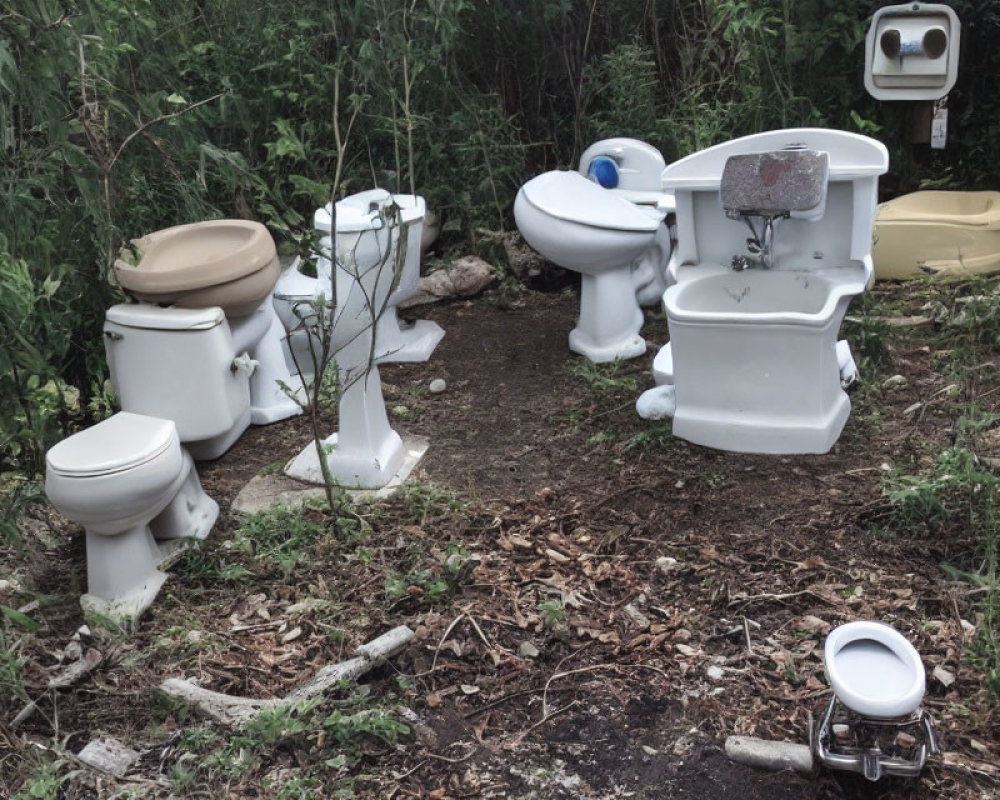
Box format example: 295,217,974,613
865,3,962,100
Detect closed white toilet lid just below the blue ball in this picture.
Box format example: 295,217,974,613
521,171,664,231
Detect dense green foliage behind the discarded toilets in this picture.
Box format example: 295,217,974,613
0,0,1000,474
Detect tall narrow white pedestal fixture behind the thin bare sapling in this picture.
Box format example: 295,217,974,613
285,201,422,489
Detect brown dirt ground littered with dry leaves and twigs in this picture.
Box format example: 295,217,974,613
7,284,1000,800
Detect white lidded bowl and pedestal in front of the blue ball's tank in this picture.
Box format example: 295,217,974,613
514,171,667,363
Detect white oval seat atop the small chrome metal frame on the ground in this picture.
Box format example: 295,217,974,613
823,621,925,719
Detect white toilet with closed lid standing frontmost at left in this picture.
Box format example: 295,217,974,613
45,412,219,625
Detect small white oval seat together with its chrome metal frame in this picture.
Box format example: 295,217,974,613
813,622,938,781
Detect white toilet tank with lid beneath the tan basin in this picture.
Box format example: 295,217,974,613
104,303,250,442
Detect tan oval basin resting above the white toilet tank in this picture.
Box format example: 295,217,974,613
115,219,280,318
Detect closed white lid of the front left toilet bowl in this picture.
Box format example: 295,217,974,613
45,411,180,477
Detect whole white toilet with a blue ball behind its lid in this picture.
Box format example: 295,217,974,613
514,138,673,363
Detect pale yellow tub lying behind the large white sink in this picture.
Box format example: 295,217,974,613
872,191,1000,280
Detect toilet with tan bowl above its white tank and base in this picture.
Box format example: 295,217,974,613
111,220,302,459
